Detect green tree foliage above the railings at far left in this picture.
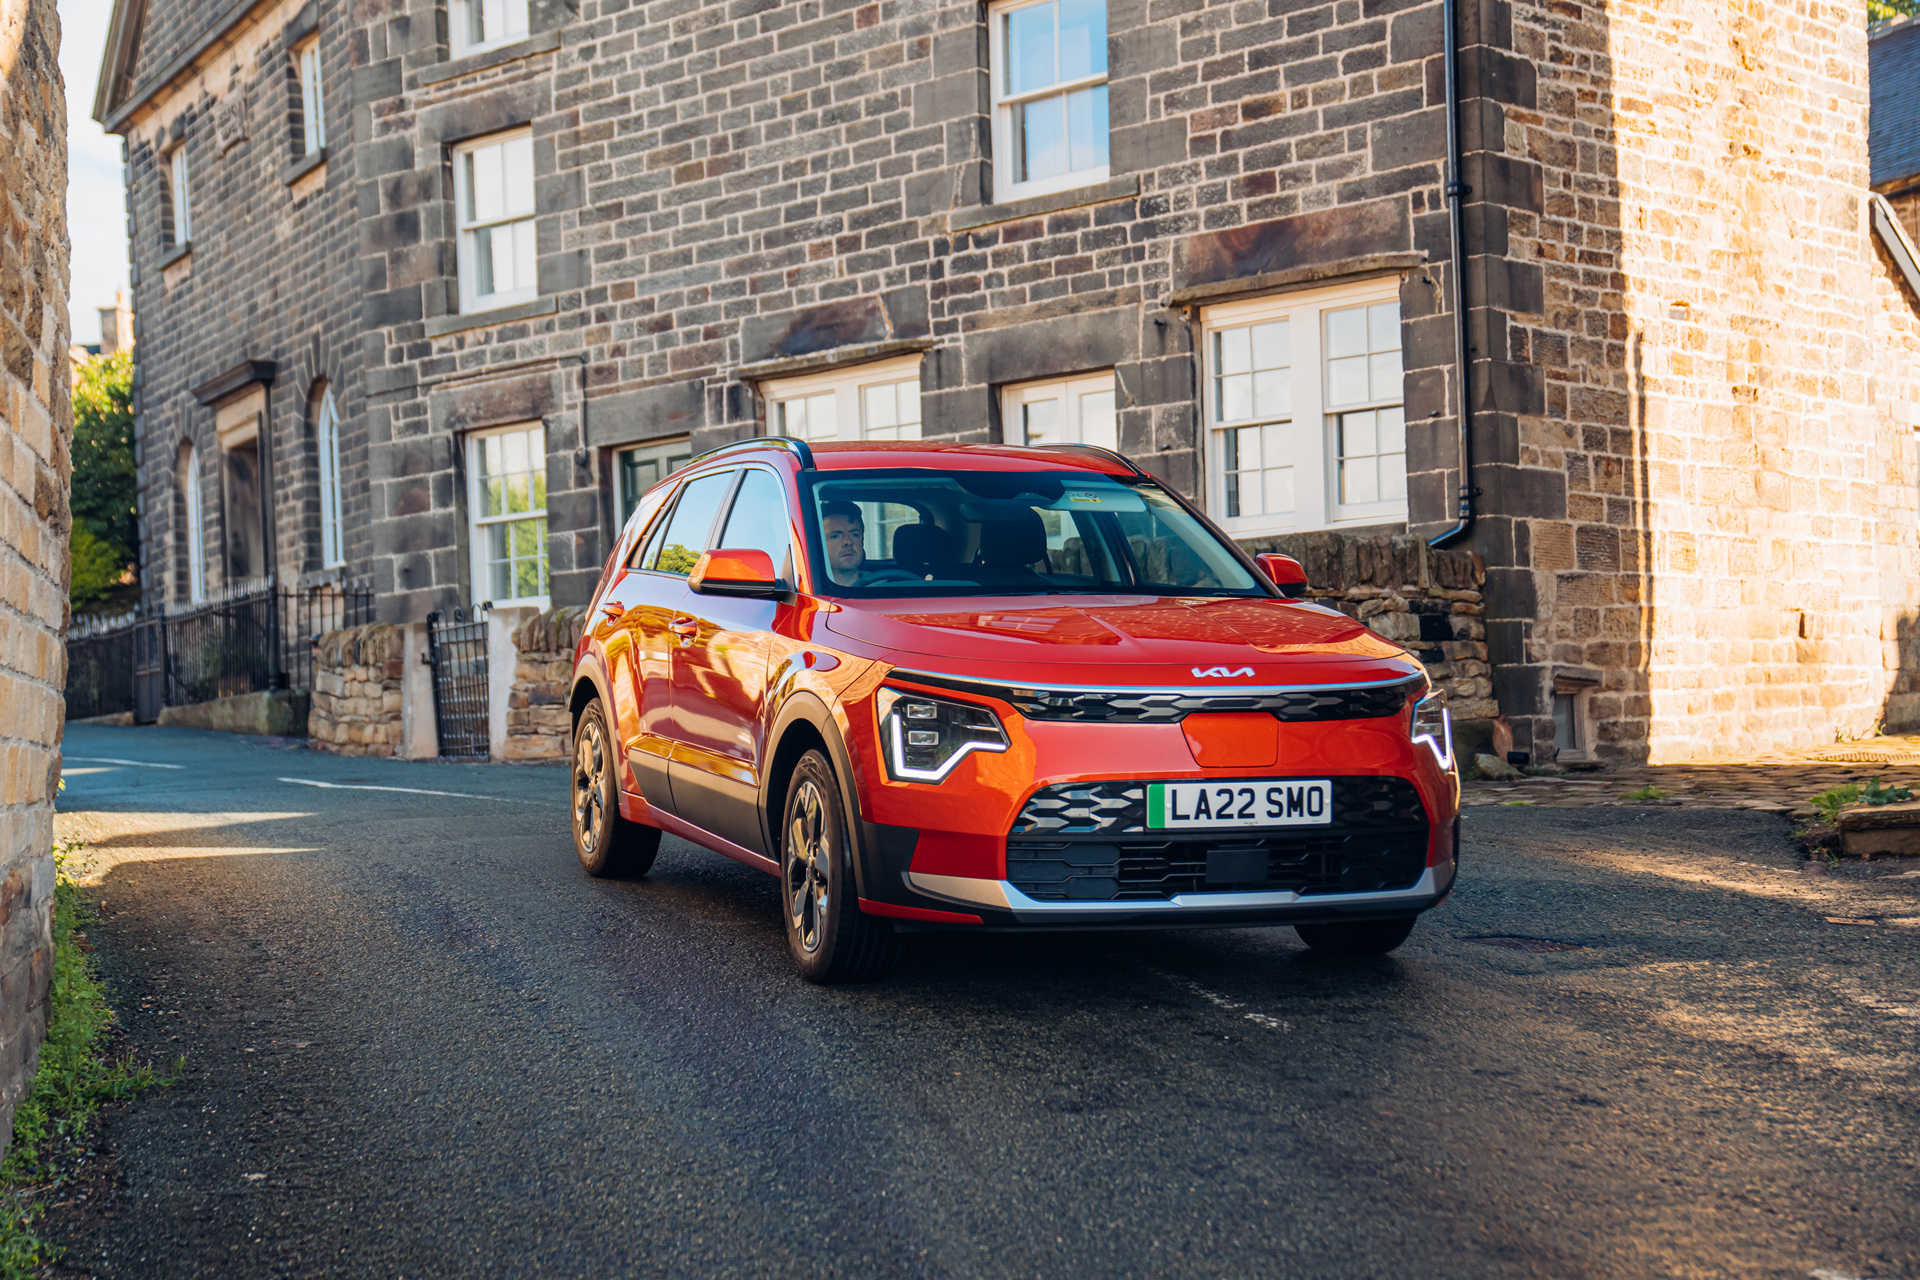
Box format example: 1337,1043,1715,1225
71,351,140,604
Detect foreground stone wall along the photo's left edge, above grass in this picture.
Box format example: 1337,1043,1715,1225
0,0,73,1151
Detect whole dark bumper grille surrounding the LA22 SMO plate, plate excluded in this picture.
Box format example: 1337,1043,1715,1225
1006,777,1427,902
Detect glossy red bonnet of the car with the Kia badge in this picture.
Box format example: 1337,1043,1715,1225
826,595,1421,687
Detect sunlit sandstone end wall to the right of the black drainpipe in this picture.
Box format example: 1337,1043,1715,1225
1469,0,1916,762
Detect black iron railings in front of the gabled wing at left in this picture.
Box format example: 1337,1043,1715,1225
67,580,374,722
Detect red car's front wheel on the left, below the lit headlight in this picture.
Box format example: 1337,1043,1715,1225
780,750,900,984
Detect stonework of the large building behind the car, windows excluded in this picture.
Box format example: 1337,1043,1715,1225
105,0,1920,760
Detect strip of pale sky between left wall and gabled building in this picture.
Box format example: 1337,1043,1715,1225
60,0,127,345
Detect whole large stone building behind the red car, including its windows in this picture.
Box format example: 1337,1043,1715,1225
96,0,1920,760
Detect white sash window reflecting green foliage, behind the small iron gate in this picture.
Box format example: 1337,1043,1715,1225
467,422,547,608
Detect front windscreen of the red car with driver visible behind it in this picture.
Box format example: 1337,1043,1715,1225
803,468,1271,599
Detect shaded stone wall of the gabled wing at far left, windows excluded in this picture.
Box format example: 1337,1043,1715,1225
115,0,374,604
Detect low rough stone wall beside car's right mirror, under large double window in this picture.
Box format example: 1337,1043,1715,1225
1246,533,1500,722
